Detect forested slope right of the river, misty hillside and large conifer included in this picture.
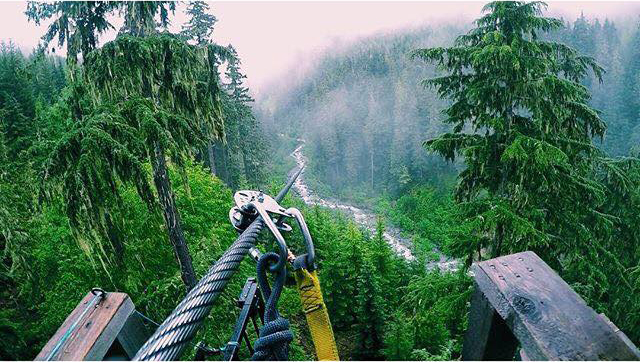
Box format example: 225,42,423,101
258,0,640,358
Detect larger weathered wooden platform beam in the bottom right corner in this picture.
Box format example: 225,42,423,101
462,251,640,360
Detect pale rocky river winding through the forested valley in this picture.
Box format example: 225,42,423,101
291,140,460,271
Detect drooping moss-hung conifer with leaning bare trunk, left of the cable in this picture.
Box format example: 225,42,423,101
37,2,222,288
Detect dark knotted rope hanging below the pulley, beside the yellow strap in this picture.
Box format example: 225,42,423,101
251,253,293,361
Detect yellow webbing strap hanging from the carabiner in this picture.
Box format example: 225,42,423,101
295,268,340,361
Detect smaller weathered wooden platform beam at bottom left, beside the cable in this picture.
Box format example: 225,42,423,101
35,292,153,361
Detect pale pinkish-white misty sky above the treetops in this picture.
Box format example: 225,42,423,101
0,1,640,94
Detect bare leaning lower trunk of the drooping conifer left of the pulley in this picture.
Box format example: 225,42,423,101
153,145,197,290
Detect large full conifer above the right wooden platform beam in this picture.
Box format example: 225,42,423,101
414,2,608,260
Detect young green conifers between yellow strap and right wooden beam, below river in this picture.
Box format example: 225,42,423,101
285,200,470,360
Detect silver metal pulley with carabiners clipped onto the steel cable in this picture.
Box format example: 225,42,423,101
229,190,315,271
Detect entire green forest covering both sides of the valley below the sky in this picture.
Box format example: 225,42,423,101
0,1,640,360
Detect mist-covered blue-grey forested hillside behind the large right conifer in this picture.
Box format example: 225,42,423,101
260,16,640,199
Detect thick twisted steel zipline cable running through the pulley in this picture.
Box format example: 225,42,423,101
133,168,302,361
